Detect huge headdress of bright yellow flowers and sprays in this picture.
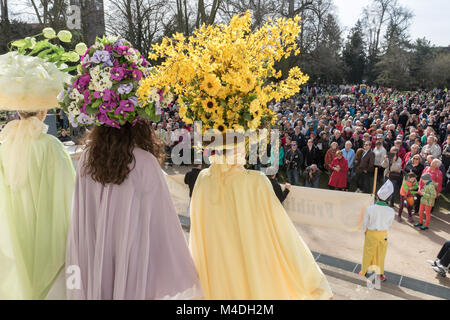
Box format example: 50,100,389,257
138,12,308,132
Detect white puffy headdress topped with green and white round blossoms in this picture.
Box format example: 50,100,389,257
0,28,86,111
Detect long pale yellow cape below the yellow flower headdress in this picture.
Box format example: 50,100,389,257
190,150,333,300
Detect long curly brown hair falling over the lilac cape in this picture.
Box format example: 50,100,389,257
83,121,164,185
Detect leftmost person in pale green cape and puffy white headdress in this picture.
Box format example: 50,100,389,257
0,53,75,299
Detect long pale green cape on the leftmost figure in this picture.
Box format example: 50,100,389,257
0,120,75,299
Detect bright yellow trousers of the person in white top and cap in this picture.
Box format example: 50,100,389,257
361,230,387,275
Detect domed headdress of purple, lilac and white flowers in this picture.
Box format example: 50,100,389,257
58,37,171,128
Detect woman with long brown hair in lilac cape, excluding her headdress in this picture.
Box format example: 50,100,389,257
66,122,203,300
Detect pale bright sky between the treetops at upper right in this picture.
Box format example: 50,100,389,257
334,0,450,46
